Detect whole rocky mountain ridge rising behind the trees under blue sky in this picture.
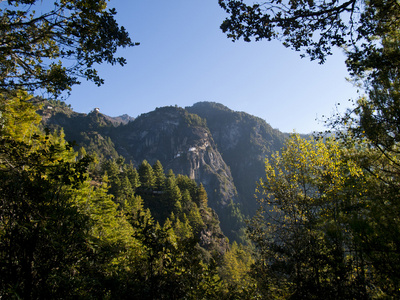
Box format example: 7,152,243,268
40,102,285,240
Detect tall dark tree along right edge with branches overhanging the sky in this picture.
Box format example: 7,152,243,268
219,0,400,298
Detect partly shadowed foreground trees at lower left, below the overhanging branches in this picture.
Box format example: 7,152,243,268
0,92,143,299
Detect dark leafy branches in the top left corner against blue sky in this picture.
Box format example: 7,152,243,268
0,0,134,95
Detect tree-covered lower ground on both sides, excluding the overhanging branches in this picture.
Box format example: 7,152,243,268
0,92,399,299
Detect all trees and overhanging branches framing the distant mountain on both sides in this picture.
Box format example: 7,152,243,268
0,0,400,299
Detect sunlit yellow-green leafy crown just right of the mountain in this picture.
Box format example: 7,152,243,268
260,135,362,210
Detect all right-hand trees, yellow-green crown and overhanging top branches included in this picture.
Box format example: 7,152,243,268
219,0,400,299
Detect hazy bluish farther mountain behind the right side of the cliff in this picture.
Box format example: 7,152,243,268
186,102,285,214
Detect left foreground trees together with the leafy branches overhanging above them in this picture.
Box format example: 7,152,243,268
0,0,141,292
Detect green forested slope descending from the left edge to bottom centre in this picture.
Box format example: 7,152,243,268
0,92,252,299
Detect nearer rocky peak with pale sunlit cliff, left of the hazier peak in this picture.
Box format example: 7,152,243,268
116,107,238,211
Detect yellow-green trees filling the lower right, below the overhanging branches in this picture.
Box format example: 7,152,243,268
248,135,400,299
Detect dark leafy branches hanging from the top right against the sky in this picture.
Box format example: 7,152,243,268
219,0,400,63
